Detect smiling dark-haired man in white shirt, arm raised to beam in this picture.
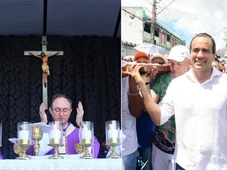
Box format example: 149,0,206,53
132,33,227,170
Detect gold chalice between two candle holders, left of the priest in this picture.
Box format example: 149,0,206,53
32,126,43,156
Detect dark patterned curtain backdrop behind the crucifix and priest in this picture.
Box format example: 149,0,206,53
0,36,121,158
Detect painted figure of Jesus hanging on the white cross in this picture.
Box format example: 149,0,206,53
29,52,60,87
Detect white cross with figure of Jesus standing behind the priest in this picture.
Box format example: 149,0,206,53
24,36,63,109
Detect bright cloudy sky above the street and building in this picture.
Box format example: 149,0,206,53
121,0,227,50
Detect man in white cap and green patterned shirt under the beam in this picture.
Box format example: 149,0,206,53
152,45,190,170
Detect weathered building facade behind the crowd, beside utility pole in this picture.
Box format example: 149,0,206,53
121,7,186,57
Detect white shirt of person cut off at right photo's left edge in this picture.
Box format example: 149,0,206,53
121,61,138,156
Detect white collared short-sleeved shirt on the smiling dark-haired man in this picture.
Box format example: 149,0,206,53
159,69,227,170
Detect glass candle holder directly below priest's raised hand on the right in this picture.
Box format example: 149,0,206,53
79,121,94,159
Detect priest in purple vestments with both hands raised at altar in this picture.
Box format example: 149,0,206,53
27,94,100,158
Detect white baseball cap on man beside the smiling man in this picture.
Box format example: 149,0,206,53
167,45,190,62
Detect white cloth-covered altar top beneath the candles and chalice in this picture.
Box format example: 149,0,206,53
0,155,122,170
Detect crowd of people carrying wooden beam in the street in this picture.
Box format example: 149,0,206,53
122,33,227,170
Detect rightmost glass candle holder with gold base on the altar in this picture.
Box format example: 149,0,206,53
105,120,120,158
